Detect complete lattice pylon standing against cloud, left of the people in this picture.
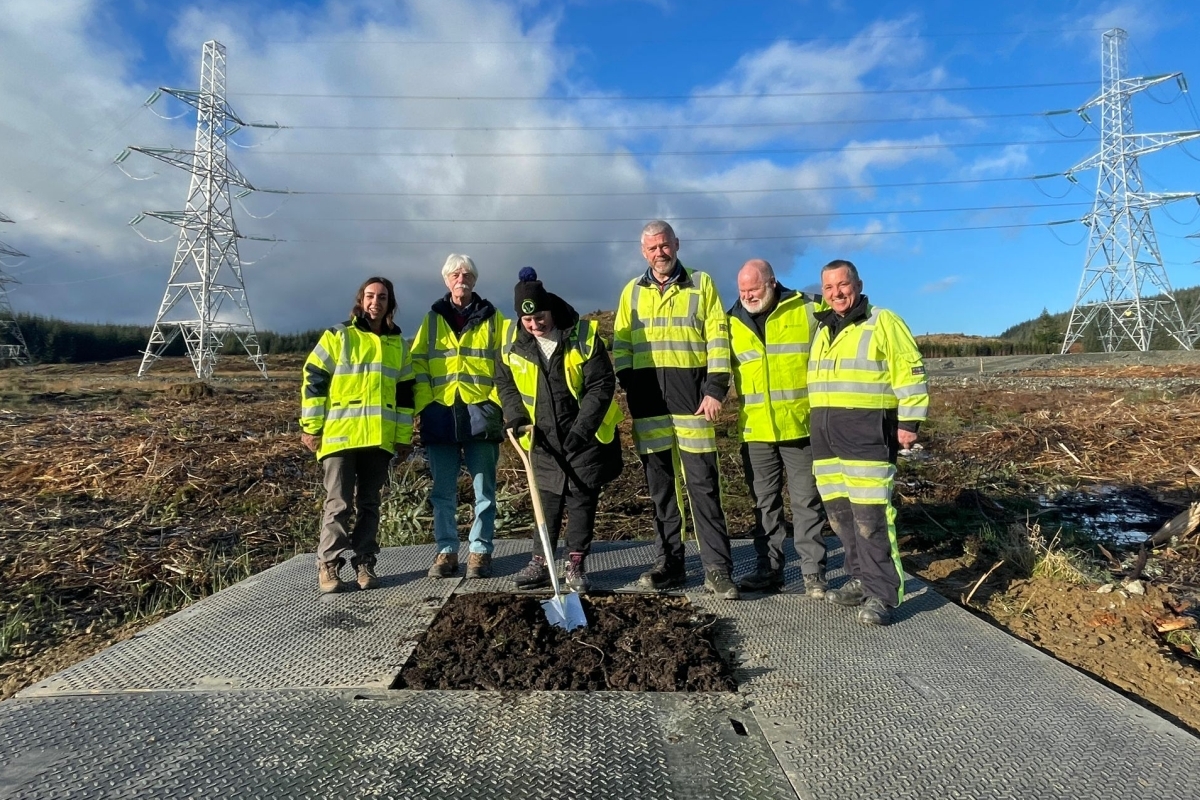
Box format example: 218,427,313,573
123,41,280,380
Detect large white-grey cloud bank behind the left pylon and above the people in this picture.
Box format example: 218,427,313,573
0,0,974,338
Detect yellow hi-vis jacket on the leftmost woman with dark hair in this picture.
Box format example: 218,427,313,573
300,318,413,458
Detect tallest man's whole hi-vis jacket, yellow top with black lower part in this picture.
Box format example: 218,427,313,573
612,264,730,417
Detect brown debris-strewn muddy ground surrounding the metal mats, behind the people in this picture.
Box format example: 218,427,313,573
0,359,1200,730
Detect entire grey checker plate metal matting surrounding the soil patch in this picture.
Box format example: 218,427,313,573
0,540,1200,800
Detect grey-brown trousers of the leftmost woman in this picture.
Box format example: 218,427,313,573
317,447,391,566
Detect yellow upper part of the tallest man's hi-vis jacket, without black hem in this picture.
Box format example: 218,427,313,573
612,267,730,372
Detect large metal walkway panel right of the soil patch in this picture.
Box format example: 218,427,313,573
696,548,1200,800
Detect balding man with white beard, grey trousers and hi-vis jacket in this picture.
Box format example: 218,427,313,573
730,259,826,599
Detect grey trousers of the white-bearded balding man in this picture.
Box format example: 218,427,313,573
742,438,826,577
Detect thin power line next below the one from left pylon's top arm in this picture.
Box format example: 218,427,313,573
243,139,1087,158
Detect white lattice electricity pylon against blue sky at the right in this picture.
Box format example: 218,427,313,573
1062,28,1200,353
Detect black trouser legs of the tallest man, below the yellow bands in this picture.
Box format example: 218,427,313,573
641,450,733,575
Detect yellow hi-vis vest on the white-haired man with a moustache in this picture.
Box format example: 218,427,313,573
413,311,509,413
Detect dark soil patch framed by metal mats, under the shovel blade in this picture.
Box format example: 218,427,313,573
392,594,737,692
